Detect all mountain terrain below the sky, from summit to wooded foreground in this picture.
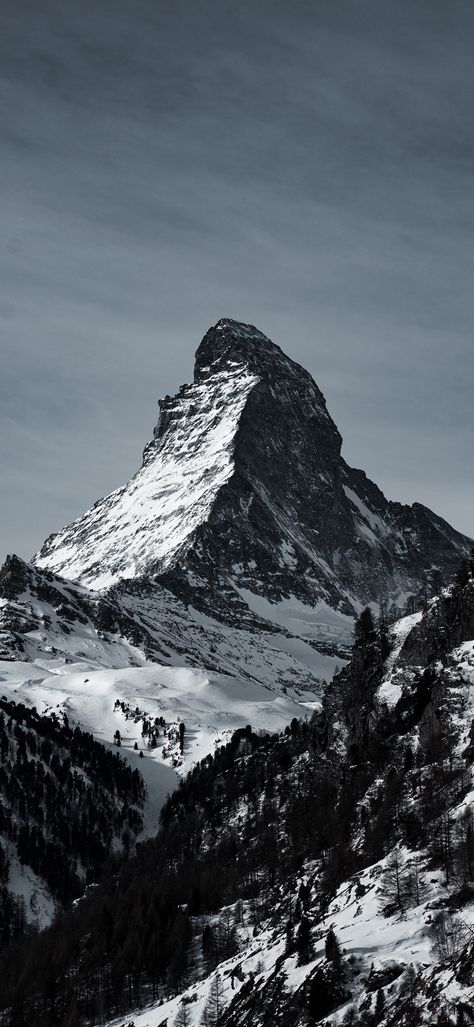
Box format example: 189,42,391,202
0,318,474,1027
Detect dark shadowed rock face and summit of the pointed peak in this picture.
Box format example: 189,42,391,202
184,322,351,599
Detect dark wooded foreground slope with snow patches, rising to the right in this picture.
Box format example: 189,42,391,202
0,568,474,1027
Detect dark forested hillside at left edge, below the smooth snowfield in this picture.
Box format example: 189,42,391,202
0,698,145,943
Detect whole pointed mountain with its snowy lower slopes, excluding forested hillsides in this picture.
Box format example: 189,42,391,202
0,319,470,858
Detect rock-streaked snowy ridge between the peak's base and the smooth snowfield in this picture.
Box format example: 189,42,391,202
0,558,342,695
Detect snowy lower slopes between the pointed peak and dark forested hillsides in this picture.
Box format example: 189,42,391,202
0,558,332,858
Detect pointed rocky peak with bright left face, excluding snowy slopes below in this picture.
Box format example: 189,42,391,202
35,319,470,643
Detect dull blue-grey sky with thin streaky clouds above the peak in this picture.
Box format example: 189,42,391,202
0,0,474,558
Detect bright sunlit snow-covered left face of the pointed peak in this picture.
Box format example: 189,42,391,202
36,364,258,588
